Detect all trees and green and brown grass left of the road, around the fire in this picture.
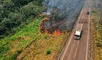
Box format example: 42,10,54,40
0,0,69,60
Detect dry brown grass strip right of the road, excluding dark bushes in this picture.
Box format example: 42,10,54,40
91,10,102,60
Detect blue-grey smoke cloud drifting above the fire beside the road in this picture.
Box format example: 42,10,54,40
43,0,85,29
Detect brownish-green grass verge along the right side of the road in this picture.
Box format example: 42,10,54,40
92,10,102,60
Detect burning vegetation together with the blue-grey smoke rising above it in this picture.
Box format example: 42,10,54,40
40,0,84,35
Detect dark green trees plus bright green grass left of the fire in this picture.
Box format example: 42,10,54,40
0,0,45,60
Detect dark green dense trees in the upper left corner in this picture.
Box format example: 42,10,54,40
0,0,42,36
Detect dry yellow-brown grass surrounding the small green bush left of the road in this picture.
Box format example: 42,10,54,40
17,34,67,60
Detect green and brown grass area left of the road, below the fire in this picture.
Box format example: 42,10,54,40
0,18,68,60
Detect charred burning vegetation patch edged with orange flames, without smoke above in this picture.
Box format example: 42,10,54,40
40,8,64,35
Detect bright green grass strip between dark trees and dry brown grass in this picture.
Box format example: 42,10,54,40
0,18,41,60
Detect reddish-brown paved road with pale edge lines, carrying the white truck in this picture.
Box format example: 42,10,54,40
58,0,91,60
